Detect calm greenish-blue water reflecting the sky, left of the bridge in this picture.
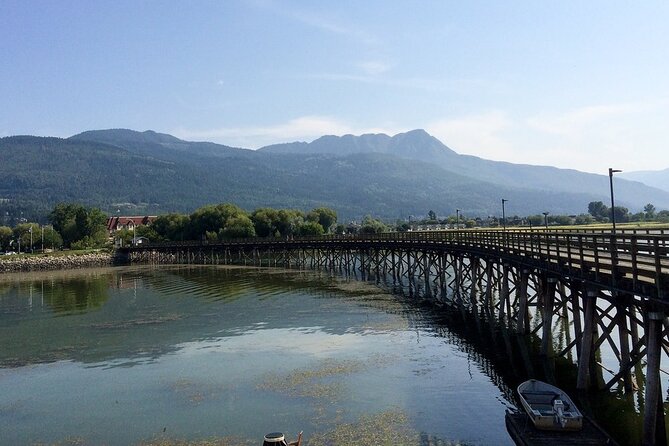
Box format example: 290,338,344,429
0,267,513,445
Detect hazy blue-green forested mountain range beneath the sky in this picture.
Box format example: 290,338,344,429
0,129,669,220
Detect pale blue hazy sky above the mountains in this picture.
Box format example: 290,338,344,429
0,0,669,173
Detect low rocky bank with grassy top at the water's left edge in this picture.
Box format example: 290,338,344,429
0,252,119,274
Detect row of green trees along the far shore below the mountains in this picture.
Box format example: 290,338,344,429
0,201,669,252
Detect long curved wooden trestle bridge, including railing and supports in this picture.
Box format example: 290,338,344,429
126,229,669,445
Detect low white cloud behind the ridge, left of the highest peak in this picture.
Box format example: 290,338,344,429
172,116,398,149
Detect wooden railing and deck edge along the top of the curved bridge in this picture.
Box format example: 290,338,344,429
130,228,669,297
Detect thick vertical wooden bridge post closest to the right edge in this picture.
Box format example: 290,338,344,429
642,312,666,446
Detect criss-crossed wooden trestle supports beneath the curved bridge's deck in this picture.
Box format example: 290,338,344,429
129,237,669,445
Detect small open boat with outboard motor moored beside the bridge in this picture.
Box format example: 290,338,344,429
518,379,583,431
